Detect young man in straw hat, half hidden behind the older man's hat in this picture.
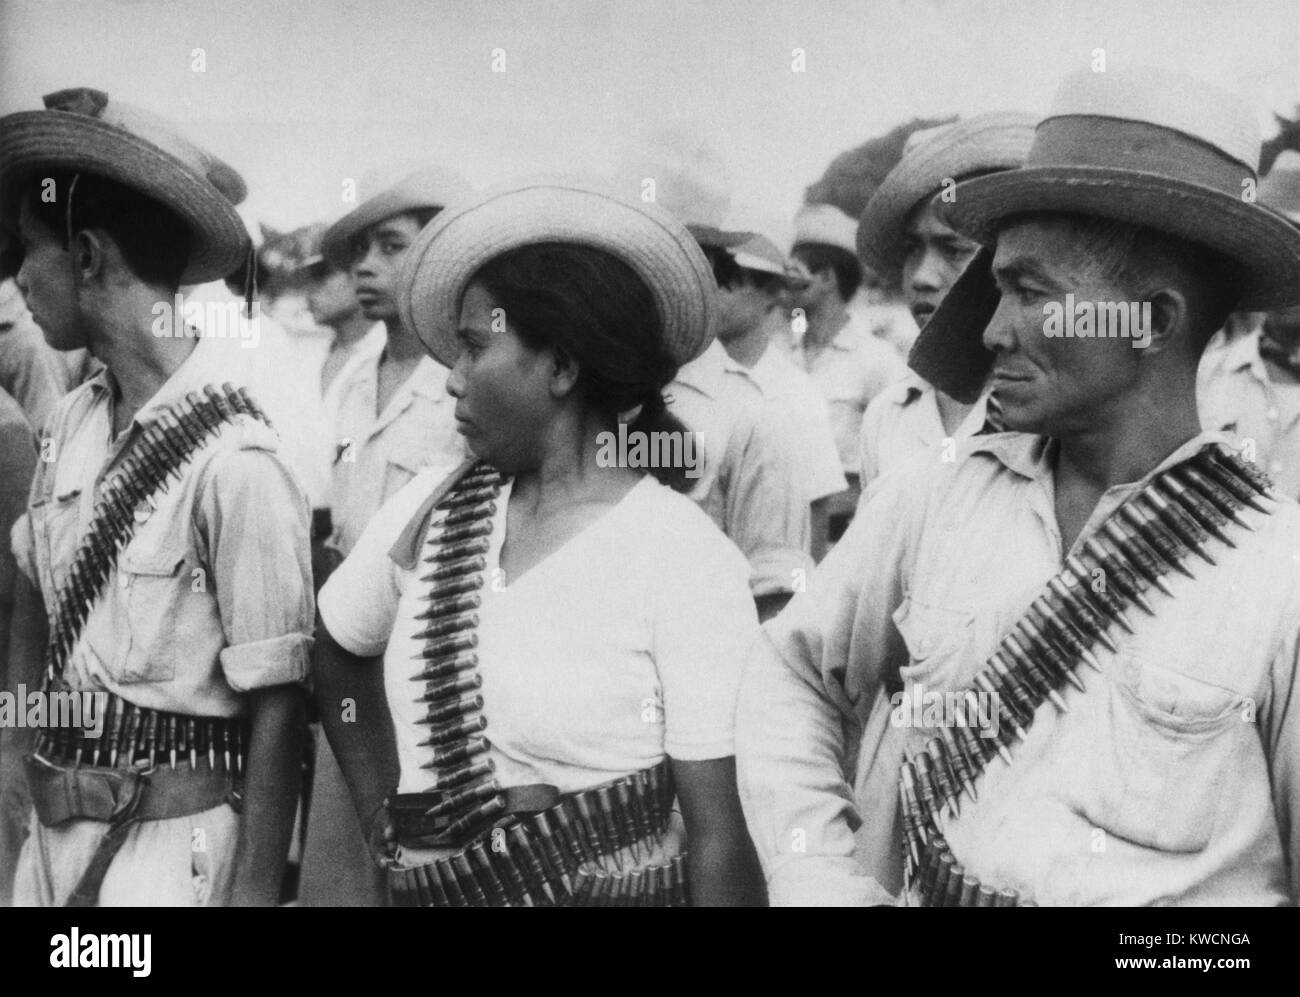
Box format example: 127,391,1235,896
858,112,1034,494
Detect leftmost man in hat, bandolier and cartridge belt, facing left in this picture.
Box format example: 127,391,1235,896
0,90,313,906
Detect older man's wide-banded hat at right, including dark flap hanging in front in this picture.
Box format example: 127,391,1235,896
907,68,1300,400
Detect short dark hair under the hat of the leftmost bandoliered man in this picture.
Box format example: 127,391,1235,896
23,170,192,291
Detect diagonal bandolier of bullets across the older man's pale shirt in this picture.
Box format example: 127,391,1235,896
898,445,1277,907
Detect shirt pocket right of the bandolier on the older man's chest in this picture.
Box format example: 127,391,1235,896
1086,655,1255,853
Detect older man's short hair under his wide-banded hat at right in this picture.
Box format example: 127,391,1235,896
1000,212,1244,348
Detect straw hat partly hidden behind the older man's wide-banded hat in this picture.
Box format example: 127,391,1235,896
857,110,1036,277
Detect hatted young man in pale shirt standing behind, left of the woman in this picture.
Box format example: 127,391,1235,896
300,166,472,906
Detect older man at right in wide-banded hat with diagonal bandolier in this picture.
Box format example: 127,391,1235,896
737,69,1300,906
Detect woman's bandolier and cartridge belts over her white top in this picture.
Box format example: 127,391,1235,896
391,463,688,907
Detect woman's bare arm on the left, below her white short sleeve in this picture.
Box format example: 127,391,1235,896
313,621,399,862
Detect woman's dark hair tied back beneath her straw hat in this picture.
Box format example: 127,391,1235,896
473,242,690,491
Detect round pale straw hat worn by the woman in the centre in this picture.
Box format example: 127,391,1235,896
398,177,716,367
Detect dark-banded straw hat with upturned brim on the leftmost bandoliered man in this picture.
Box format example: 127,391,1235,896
0,87,250,283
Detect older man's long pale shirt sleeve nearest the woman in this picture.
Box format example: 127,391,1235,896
736,467,913,906
